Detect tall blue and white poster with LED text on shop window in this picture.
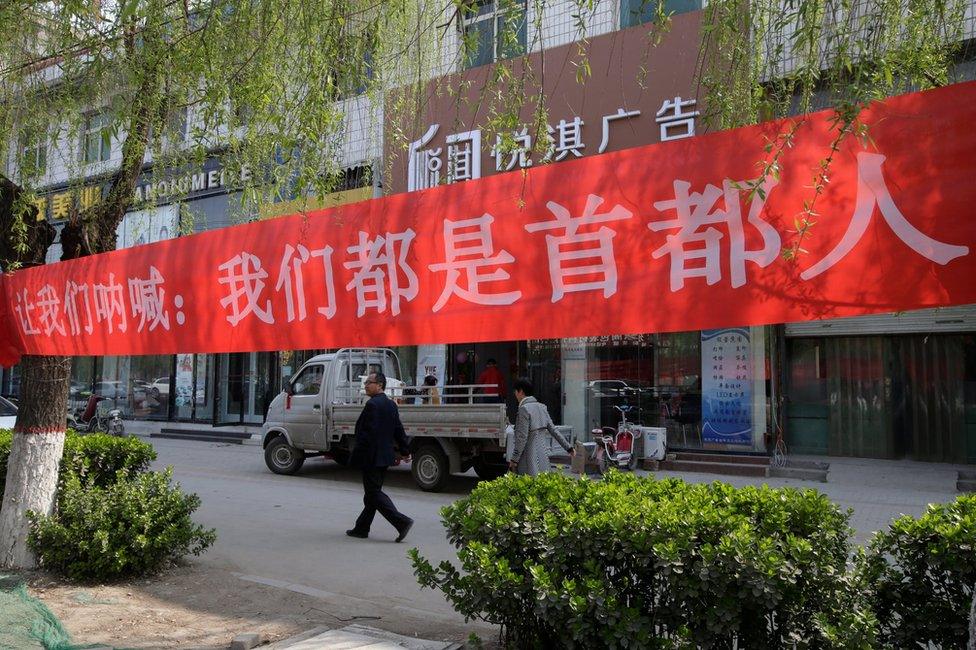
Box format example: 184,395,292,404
702,327,753,446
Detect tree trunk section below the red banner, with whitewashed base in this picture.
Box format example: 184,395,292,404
0,356,71,569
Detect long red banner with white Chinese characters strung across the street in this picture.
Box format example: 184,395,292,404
0,83,976,364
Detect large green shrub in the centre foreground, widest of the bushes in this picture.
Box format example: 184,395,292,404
411,473,874,648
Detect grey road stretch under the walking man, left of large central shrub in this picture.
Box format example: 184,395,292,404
151,438,494,640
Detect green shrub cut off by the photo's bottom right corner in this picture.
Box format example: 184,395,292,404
859,495,976,648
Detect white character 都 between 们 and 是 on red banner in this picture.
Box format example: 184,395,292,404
343,228,418,317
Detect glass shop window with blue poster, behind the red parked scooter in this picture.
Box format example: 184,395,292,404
564,327,767,451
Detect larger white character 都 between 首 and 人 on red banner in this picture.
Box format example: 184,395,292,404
647,178,781,291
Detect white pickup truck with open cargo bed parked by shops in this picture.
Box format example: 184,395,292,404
262,348,536,491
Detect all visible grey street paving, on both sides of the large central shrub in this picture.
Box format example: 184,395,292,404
152,439,956,639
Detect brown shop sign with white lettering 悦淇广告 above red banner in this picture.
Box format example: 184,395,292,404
383,12,703,193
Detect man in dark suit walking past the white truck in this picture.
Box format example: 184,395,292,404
346,372,413,542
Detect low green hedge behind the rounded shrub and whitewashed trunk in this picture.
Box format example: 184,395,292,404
0,429,156,498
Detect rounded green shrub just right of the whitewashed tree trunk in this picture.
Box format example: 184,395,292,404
28,469,216,580
